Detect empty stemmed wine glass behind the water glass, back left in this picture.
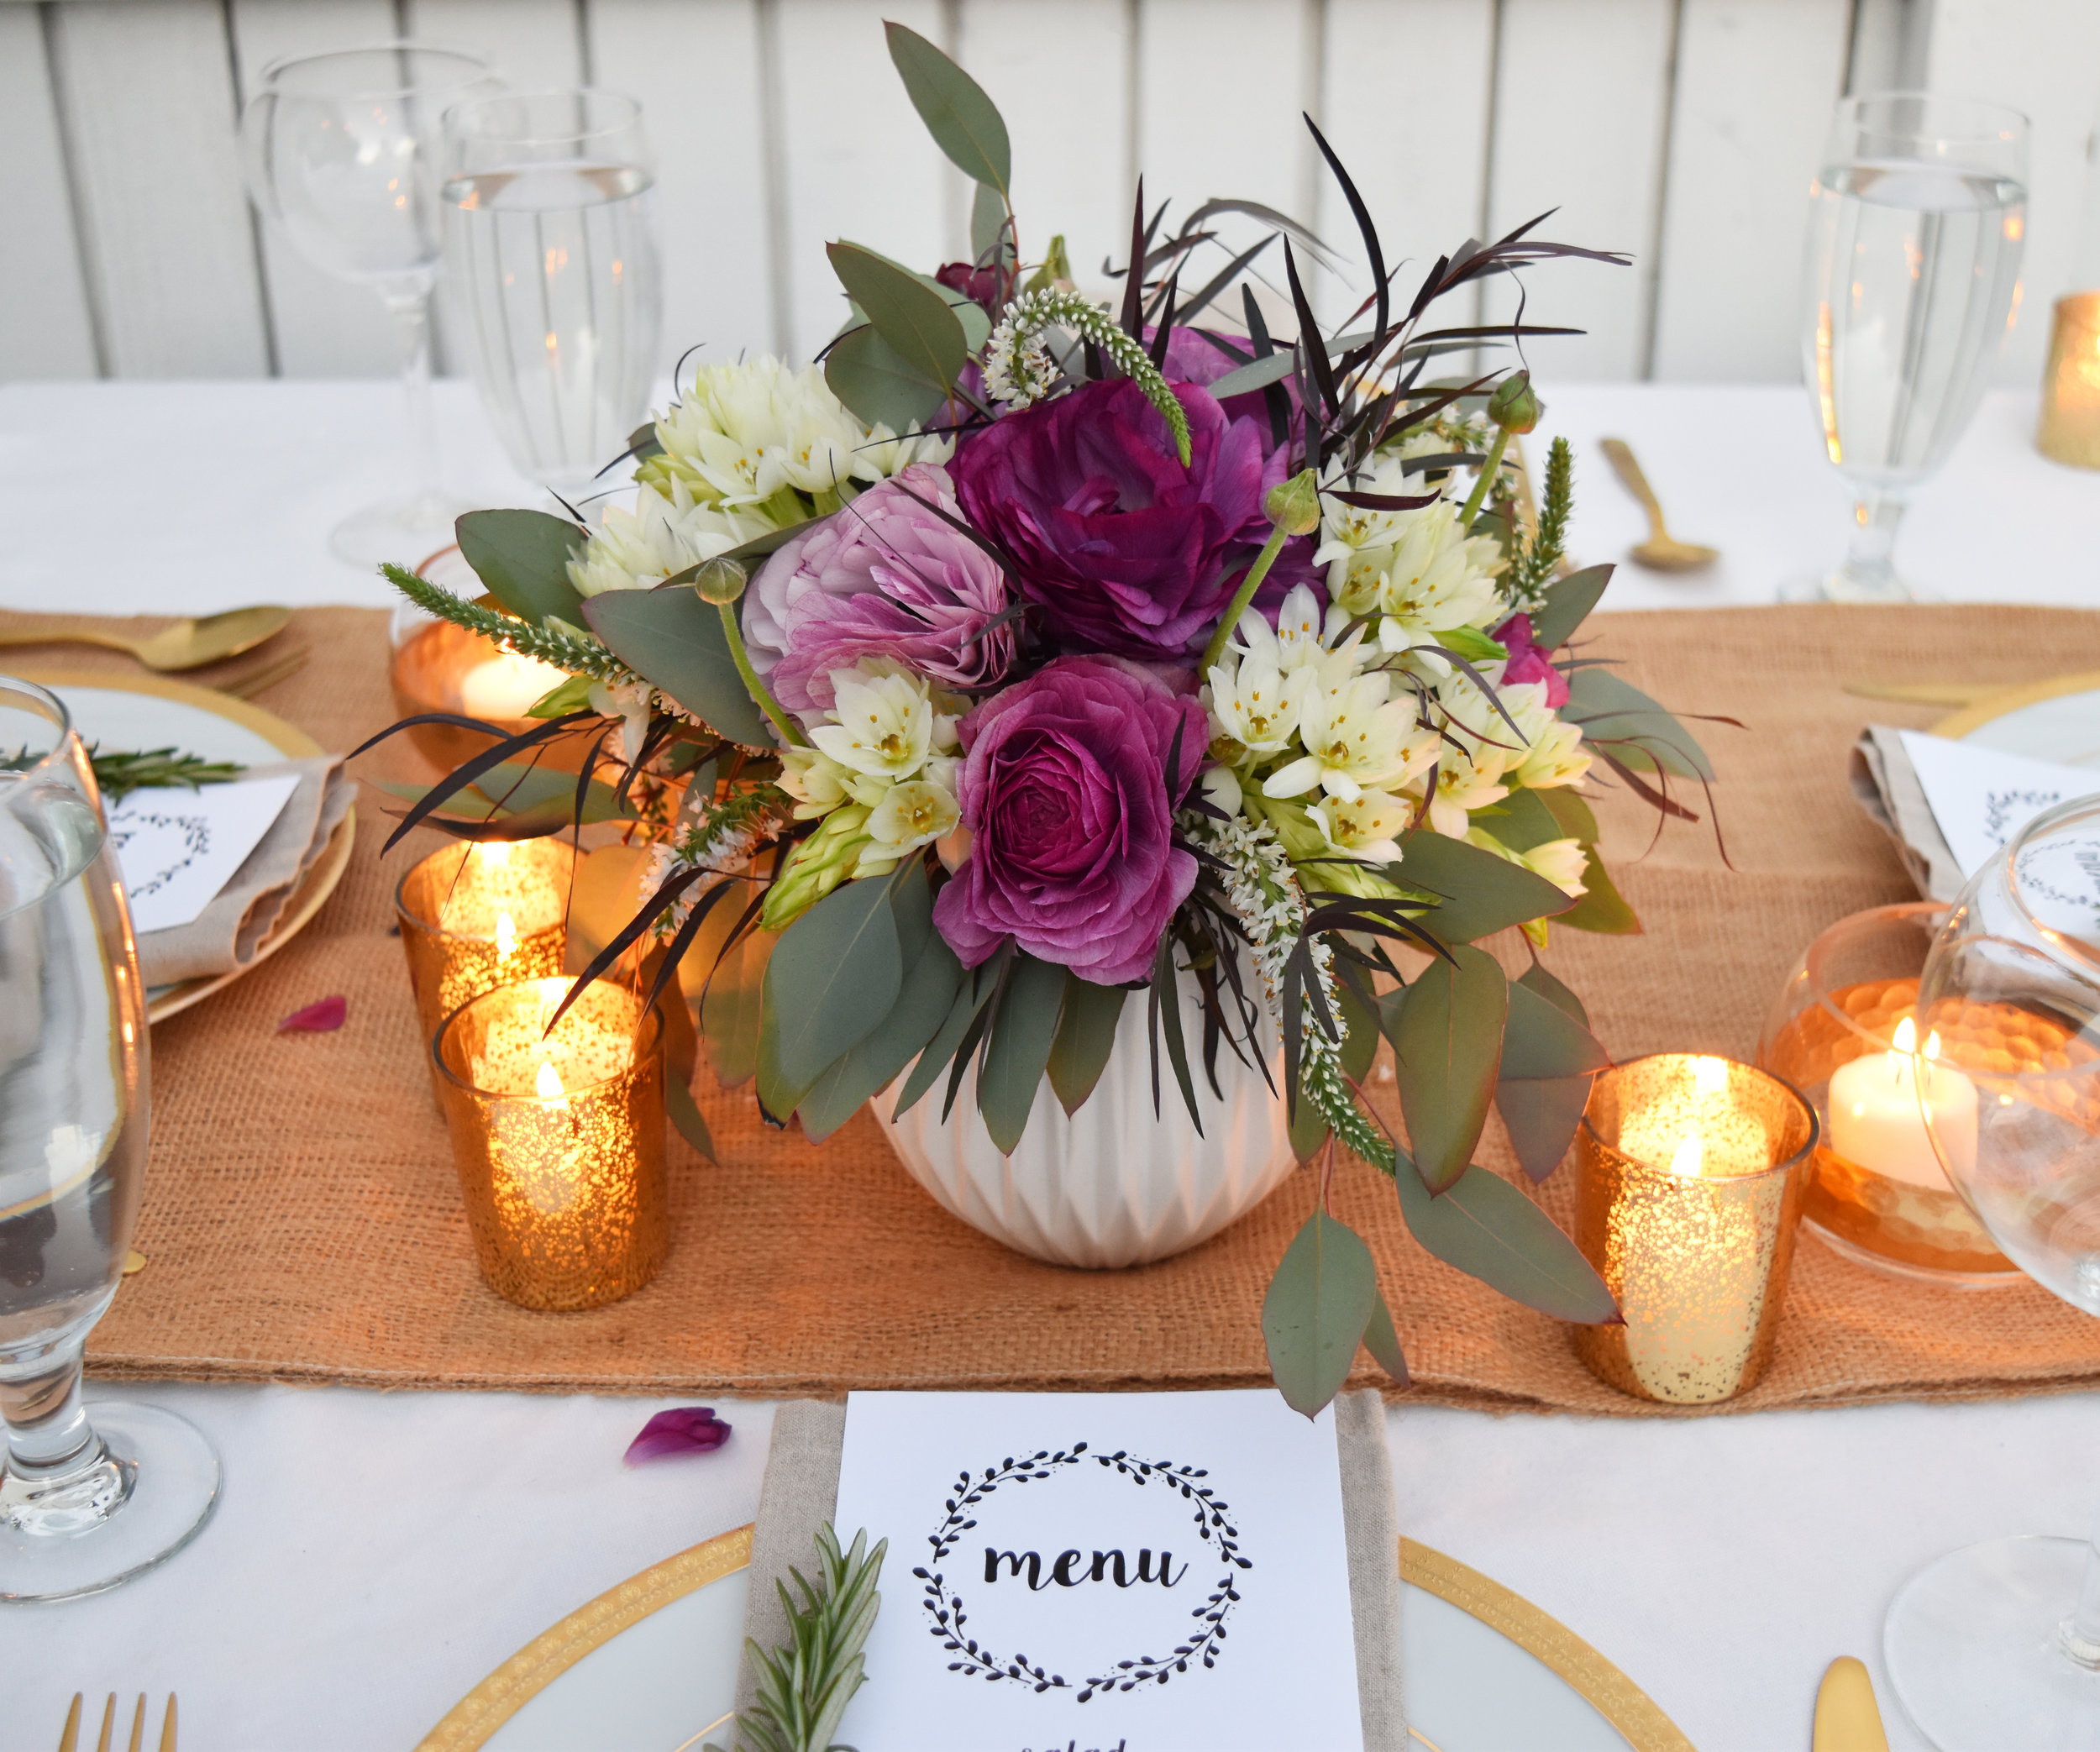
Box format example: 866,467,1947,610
242,42,500,567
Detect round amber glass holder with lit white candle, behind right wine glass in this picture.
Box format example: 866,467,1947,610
1758,901,2020,1290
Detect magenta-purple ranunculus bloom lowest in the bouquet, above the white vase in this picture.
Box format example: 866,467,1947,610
932,658,1205,985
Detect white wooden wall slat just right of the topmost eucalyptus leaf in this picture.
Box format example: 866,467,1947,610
956,0,1132,288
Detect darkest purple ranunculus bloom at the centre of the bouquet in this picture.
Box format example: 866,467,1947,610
953,378,1281,662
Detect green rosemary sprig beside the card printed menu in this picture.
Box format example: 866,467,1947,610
706,1523,890,1752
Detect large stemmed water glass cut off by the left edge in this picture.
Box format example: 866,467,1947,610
0,676,218,1601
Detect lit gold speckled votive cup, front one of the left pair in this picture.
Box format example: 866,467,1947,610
435,977,670,1311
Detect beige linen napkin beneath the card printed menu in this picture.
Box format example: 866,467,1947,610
738,1388,1407,1752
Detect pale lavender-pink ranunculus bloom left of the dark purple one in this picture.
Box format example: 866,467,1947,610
743,462,1015,712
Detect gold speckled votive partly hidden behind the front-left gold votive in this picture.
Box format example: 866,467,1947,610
395,838,575,1067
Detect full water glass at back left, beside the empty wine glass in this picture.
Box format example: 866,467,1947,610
444,91,664,498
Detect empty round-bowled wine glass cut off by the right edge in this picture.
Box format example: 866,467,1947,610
1884,796,2100,1752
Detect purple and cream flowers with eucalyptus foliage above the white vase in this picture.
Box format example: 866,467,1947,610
370,25,1709,1409
